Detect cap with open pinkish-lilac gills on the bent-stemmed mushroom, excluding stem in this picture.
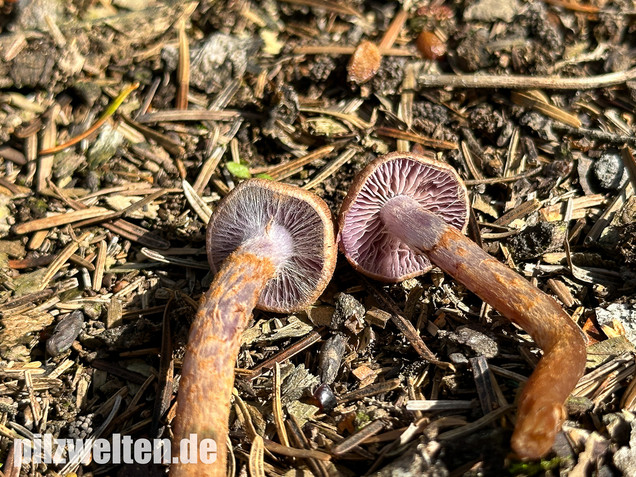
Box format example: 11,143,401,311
338,152,469,283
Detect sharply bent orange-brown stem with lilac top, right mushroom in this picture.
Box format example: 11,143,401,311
380,196,586,459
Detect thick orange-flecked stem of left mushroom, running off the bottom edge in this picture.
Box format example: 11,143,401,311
170,248,276,477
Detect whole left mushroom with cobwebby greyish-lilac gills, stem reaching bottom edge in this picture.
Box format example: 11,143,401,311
171,179,337,476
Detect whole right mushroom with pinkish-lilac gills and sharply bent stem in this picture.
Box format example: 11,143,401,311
339,153,586,458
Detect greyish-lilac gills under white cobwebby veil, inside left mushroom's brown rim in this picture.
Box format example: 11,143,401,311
207,181,325,309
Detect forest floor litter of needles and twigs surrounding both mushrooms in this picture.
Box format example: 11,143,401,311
0,0,636,475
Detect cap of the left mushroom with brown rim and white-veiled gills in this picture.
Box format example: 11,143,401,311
206,179,337,313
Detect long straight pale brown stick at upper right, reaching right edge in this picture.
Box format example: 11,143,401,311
417,68,636,89
